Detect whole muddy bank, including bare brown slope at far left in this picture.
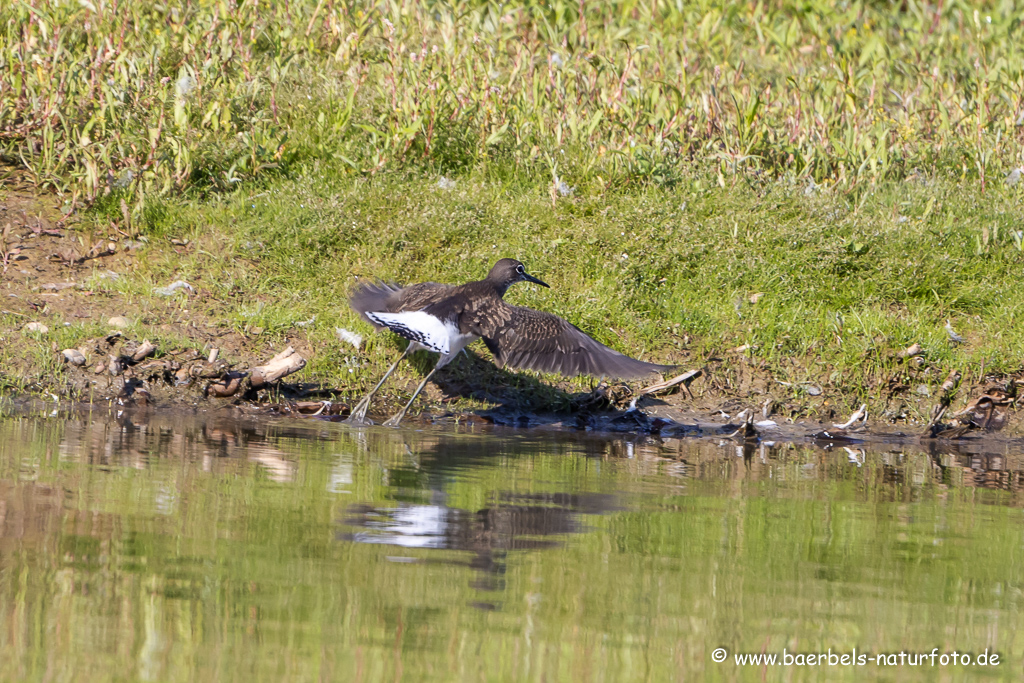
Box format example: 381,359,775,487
0,187,1024,439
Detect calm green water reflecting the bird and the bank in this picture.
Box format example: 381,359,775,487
0,413,1024,681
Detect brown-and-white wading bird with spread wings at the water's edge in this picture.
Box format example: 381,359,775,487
349,258,671,426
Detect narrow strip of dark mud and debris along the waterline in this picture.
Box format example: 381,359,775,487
14,321,1024,444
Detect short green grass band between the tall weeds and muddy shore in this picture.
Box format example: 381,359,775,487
64,171,1024,417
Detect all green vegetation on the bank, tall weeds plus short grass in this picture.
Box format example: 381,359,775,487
0,0,1024,409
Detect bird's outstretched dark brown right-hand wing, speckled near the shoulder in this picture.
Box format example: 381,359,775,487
475,302,672,379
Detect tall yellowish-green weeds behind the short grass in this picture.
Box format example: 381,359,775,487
6,0,1024,202
